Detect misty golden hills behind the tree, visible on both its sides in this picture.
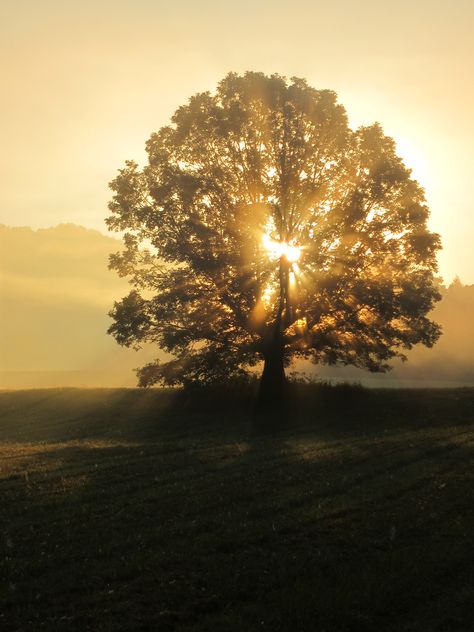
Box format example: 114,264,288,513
0,225,474,388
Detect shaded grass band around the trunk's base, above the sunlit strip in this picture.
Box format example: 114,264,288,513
0,384,474,442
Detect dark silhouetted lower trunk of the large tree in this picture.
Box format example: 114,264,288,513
256,339,287,415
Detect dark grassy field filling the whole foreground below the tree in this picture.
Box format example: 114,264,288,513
0,385,474,632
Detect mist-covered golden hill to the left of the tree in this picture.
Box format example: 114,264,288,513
0,224,156,388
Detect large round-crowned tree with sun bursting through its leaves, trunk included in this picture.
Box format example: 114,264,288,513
107,72,440,406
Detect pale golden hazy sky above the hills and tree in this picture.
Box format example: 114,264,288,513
0,0,474,283
